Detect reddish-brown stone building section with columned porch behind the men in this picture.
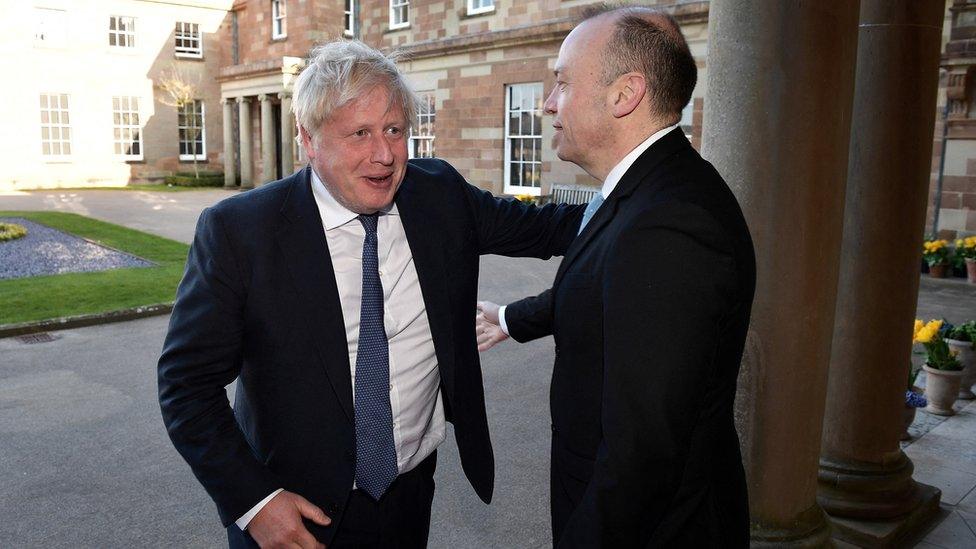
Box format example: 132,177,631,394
217,0,708,195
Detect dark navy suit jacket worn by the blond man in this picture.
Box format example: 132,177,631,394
158,160,582,544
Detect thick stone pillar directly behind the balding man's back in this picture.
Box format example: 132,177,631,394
703,0,858,547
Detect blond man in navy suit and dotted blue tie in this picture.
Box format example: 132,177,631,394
158,41,582,547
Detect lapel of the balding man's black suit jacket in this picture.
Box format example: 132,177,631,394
552,128,691,289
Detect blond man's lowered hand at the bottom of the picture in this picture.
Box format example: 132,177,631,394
247,491,332,549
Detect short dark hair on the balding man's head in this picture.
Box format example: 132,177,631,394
583,4,698,118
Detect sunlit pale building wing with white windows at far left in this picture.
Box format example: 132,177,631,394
0,0,231,190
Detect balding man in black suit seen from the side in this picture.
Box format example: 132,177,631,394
479,8,755,548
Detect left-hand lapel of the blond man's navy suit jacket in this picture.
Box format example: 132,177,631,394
275,167,353,422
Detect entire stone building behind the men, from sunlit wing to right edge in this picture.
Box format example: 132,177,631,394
0,0,976,238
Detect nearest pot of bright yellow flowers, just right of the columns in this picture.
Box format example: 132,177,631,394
912,320,962,416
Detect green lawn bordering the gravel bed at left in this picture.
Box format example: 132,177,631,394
0,211,189,325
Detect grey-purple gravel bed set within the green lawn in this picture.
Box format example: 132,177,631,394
0,218,154,279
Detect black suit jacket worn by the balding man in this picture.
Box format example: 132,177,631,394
506,129,755,547
